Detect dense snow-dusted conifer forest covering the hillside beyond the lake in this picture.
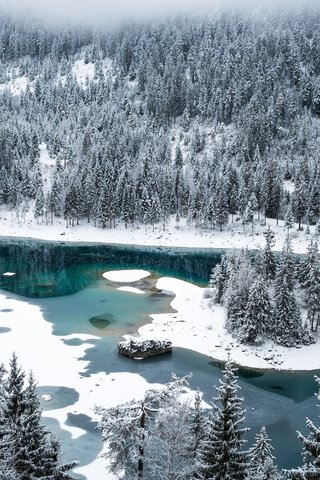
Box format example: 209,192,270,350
0,9,320,229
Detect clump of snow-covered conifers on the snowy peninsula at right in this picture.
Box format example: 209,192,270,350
209,232,320,346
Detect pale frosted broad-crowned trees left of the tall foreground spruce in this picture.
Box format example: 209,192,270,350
96,376,196,480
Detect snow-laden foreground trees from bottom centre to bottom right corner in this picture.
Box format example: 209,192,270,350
96,359,320,480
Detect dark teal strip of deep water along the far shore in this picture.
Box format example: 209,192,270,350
0,238,223,298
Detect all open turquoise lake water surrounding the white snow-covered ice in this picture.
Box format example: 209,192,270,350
0,239,320,468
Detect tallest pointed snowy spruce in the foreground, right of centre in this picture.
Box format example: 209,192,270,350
200,360,248,480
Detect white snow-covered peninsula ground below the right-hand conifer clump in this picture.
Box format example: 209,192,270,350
139,277,320,370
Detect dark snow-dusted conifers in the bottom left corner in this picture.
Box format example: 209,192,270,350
0,354,77,480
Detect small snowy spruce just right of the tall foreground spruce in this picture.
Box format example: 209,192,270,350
248,426,280,480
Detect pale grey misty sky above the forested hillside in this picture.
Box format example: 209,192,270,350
0,0,318,21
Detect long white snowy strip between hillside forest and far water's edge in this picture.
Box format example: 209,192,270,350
0,206,317,253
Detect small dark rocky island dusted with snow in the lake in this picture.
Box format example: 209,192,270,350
118,340,172,359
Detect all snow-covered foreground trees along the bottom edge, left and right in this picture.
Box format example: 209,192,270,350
0,354,320,480
